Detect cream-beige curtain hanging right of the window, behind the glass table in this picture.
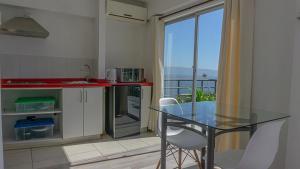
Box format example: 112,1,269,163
216,0,254,151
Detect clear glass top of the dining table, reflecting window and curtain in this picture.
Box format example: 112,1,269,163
150,101,289,130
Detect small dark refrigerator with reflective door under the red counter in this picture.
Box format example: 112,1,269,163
105,85,141,138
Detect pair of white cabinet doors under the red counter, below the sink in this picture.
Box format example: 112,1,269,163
63,87,104,138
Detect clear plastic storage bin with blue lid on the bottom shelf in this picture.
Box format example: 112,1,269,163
15,118,54,140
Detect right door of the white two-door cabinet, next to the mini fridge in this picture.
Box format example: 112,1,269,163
84,88,104,136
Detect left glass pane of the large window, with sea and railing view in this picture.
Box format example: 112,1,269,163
164,18,195,100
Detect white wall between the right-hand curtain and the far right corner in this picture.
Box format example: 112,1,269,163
252,0,299,169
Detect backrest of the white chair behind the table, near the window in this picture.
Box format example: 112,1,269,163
157,98,184,136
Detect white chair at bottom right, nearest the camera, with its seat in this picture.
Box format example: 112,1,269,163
215,120,285,169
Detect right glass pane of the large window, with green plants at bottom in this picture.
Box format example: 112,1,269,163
196,8,223,101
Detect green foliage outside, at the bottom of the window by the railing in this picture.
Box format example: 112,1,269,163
177,88,216,103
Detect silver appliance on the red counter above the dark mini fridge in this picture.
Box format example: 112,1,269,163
106,68,144,82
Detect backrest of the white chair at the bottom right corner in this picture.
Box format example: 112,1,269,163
237,120,285,169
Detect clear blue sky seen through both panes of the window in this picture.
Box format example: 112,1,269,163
164,9,223,70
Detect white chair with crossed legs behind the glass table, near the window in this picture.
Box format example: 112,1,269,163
156,98,207,169
